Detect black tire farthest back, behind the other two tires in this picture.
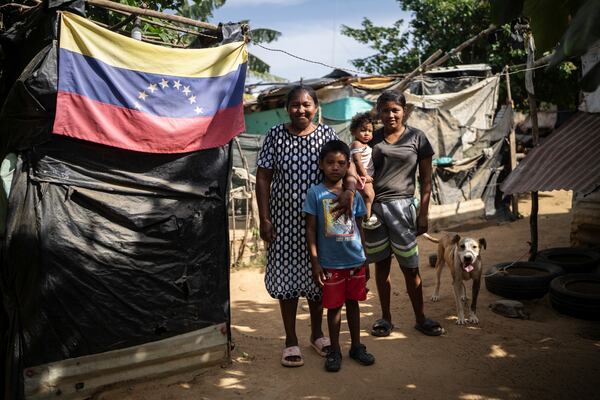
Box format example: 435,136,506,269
535,247,600,274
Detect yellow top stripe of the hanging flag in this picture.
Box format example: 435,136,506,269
60,12,248,78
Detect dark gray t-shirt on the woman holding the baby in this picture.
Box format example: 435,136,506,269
369,126,435,203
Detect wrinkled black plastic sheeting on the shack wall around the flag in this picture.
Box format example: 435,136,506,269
0,1,235,400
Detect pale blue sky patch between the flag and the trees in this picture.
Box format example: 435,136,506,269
210,0,409,81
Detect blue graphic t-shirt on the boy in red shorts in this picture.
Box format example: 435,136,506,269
302,183,367,269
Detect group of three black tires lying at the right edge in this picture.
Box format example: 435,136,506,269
485,247,600,320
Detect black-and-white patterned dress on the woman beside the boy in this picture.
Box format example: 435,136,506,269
256,124,338,301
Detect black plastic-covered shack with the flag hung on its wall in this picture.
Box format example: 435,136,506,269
0,1,247,400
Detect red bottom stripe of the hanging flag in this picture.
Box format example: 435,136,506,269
53,92,245,153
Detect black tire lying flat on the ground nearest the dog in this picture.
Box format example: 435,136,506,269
485,261,564,300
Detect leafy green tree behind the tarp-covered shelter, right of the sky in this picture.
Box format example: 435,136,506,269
342,0,578,109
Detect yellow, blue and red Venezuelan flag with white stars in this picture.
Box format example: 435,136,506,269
53,12,248,153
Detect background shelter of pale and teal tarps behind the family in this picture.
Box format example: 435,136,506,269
242,64,512,227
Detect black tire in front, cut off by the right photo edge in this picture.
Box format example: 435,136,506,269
550,274,600,321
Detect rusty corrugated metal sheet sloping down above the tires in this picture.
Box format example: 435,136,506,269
500,112,600,194
